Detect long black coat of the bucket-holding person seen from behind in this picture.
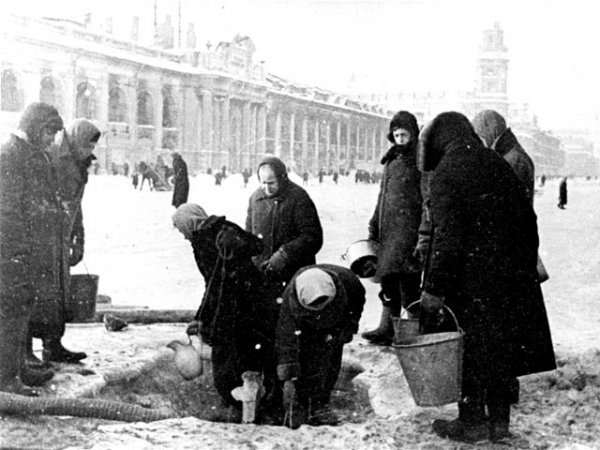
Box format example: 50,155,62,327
423,128,556,381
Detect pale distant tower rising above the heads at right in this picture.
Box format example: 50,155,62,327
474,22,508,117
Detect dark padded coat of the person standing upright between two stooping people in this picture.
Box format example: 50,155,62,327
246,179,323,281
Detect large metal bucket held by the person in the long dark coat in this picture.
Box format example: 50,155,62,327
393,307,464,406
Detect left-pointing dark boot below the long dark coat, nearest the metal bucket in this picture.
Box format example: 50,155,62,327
432,400,490,443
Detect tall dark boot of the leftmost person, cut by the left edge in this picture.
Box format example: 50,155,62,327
0,316,39,397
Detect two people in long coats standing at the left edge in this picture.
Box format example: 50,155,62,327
0,103,101,396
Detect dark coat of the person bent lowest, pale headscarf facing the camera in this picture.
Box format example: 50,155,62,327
276,264,365,400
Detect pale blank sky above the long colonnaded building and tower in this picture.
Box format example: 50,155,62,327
3,0,600,128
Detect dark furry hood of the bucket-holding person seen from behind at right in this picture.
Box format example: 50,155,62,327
417,111,481,172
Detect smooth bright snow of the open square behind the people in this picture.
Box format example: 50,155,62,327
75,171,600,351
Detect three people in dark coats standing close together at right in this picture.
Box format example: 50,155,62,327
363,110,556,441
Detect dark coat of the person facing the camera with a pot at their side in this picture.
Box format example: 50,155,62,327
369,146,423,277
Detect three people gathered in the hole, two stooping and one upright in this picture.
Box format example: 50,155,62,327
173,156,365,428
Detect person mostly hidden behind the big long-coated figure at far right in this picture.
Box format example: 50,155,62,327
472,109,535,205
